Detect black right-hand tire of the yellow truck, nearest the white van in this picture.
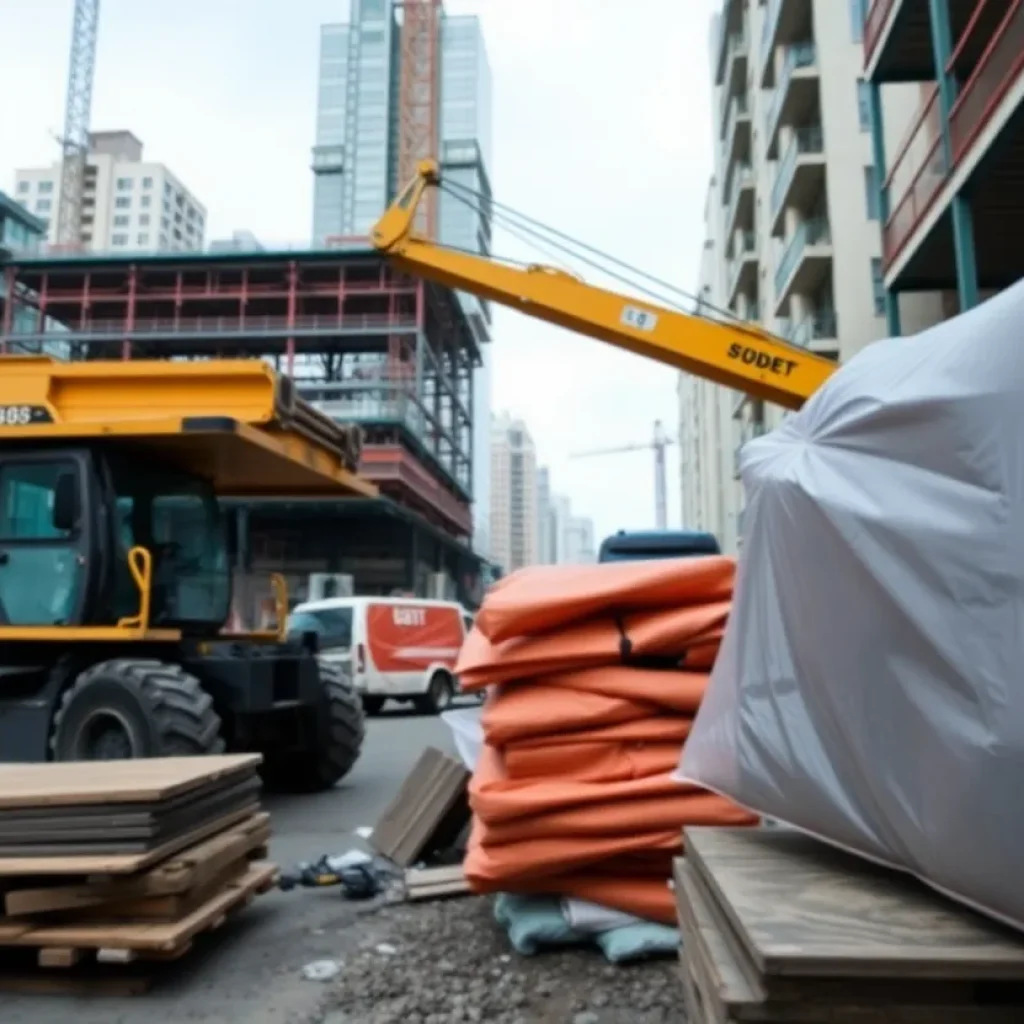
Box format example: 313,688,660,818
264,660,367,793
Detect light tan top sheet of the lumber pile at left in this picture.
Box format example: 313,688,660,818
0,754,263,809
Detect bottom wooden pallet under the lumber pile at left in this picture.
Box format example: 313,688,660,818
0,862,279,994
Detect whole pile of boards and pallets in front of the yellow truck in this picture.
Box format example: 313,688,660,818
0,755,278,991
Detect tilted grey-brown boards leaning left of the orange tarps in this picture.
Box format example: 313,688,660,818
371,746,470,867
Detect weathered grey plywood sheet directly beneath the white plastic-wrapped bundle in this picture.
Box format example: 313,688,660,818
684,828,1024,981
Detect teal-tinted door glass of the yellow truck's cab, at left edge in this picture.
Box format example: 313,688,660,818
0,461,82,626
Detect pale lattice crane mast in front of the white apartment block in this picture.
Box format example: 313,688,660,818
56,0,99,246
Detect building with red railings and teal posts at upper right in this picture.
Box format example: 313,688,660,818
863,0,1024,325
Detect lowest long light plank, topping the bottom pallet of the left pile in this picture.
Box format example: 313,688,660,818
0,864,279,956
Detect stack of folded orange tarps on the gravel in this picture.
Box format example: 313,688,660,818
456,557,755,924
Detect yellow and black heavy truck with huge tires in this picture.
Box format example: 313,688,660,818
0,356,376,791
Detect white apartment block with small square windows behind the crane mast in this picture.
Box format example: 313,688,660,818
14,131,206,252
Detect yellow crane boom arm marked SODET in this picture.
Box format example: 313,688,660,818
370,161,836,409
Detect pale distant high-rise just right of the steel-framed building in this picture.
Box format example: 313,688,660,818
488,413,540,572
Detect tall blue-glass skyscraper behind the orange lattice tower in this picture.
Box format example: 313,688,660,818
312,0,492,554
